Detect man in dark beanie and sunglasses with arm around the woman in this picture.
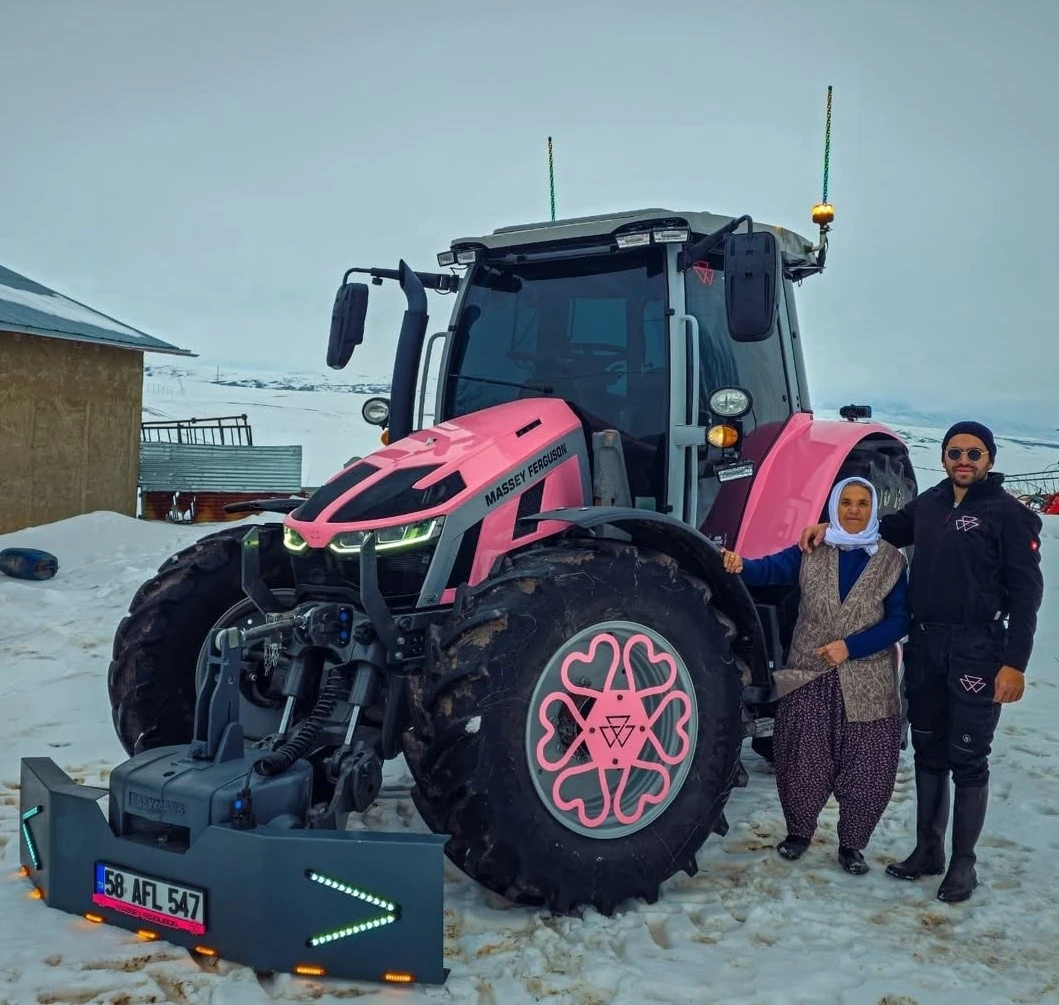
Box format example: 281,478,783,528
798,421,1044,901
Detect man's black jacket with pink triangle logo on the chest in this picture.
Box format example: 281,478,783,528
879,472,1044,670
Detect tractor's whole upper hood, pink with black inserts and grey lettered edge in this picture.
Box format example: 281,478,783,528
284,398,584,548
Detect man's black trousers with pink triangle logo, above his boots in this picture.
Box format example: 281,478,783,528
904,621,1007,787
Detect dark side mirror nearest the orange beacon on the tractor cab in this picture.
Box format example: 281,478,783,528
724,230,783,342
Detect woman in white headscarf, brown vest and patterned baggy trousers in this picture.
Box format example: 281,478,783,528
723,478,909,876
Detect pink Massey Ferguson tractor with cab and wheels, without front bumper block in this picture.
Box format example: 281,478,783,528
109,210,917,914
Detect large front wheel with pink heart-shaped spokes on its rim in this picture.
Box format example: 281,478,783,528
406,541,743,915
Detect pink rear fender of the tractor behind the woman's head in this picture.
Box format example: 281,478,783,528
734,412,900,558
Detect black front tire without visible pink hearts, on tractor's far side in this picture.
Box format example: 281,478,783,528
107,524,293,755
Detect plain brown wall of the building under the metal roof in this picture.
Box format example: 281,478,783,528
0,331,143,534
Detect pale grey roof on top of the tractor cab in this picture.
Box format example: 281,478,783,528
451,209,818,272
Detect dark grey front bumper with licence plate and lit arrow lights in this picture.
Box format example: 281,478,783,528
19,757,448,984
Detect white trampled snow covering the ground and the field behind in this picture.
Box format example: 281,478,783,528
0,371,1059,1005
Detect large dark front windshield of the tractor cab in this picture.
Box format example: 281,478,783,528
445,248,668,438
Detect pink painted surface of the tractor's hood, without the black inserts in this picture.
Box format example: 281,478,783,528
284,398,580,548
